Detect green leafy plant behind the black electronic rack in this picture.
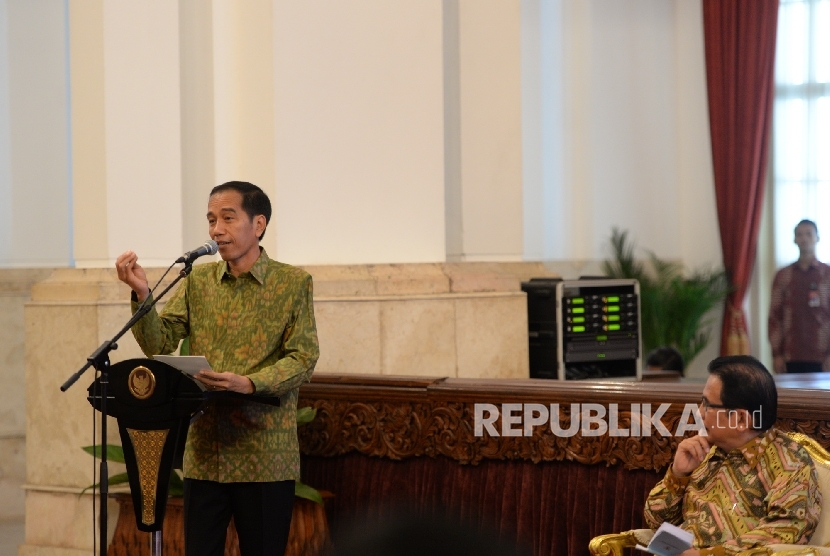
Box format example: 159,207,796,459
603,228,729,365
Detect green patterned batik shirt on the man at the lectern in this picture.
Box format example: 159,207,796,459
132,249,320,483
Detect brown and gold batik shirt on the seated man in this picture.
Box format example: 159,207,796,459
645,428,821,556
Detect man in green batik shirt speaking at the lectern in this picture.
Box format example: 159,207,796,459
111,181,319,556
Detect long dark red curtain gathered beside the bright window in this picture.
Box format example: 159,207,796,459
703,0,778,355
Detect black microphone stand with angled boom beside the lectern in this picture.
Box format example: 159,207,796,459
61,260,193,556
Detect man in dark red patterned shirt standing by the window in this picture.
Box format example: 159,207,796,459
769,220,830,373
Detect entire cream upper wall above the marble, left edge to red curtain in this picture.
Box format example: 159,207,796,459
0,0,720,267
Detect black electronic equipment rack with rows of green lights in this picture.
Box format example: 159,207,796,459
522,278,642,380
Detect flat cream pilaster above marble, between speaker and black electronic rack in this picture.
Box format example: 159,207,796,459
444,0,524,261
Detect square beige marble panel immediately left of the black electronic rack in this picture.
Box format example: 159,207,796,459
455,293,530,378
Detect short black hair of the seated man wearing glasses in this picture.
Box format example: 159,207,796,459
709,355,778,431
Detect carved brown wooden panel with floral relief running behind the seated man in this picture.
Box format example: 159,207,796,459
299,376,830,469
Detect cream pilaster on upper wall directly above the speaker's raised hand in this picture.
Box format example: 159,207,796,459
69,0,184,267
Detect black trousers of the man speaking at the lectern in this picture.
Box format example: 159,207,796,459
184,479,294,556
